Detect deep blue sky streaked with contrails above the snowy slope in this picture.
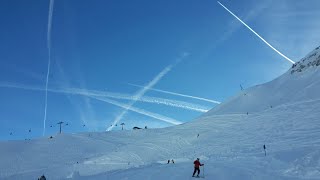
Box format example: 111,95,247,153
0,0,320,140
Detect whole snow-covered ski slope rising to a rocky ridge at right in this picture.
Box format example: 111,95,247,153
0,48,320,180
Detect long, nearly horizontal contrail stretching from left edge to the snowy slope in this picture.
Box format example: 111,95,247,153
0,82,212,112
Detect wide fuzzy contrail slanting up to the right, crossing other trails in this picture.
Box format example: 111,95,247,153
107,52,189,131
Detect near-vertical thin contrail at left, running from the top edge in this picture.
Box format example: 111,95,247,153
42,0,54,136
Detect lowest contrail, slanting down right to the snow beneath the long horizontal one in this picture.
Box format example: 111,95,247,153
91,96,182,125
